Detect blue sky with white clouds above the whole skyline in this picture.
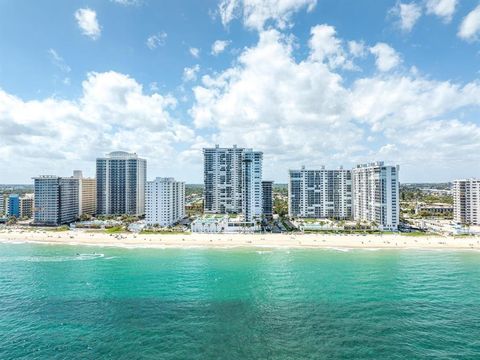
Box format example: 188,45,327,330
0,0,480,183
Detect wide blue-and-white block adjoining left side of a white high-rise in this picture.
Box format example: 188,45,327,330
288,167,352,219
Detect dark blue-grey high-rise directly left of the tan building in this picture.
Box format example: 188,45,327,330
33,175,78,226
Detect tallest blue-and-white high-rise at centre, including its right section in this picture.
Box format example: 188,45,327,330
203,145,263,221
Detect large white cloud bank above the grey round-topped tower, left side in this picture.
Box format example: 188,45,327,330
0,71,194,178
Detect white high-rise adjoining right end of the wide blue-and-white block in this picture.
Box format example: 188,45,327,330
352,161,400,230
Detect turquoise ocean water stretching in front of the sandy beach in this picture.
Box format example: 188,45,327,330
0,244,480,359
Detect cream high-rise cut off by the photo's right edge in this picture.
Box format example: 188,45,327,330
453,179,480,225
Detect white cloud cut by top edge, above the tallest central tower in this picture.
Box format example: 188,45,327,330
218,0,317,30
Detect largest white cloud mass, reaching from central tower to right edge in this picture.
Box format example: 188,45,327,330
188,27,480,179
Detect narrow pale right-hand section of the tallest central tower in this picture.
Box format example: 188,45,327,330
242,149,263,222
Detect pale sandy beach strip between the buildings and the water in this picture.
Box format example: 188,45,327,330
0,228,480,250
